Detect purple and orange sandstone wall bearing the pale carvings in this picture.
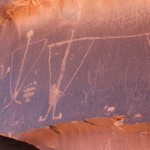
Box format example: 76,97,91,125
0,0,150,135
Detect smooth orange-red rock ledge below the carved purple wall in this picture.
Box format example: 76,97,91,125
18,118,150,150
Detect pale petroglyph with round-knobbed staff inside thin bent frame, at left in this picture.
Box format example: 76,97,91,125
4,30,47,109
